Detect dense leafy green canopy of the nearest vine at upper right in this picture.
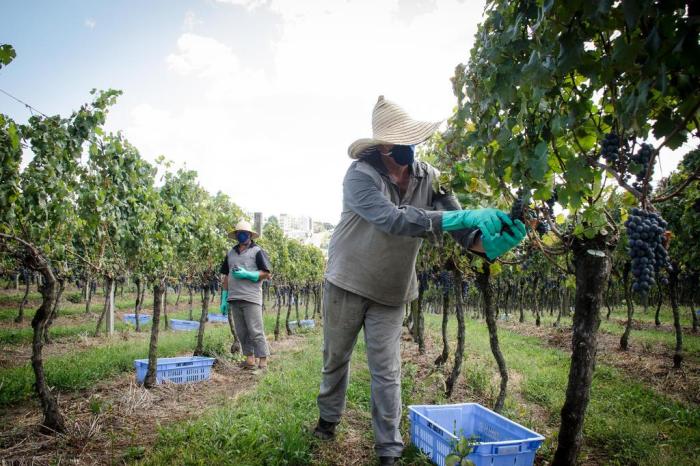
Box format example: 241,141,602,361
443,0,700,244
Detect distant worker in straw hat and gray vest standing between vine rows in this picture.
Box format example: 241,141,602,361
220,221,271,369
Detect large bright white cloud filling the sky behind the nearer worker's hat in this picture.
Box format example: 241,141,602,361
125,0,483,222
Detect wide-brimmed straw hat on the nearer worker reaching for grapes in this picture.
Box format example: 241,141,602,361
348,95,442,159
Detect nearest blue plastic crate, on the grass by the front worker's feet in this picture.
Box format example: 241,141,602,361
408,403,544,466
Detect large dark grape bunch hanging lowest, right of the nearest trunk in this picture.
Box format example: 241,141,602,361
625,208,671,294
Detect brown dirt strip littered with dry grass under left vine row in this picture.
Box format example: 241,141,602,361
0,336,303,466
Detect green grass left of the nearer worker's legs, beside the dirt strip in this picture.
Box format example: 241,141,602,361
144,332,328,466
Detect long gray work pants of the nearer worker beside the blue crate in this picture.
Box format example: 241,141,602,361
317,282,403,457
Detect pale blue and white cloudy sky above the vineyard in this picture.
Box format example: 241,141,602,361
0,0,684,223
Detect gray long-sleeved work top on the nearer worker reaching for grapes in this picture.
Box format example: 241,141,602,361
326,152,478,306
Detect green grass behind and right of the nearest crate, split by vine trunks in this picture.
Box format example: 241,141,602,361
427,315,700,465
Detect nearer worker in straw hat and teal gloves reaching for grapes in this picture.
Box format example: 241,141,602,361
314,96,525,465
